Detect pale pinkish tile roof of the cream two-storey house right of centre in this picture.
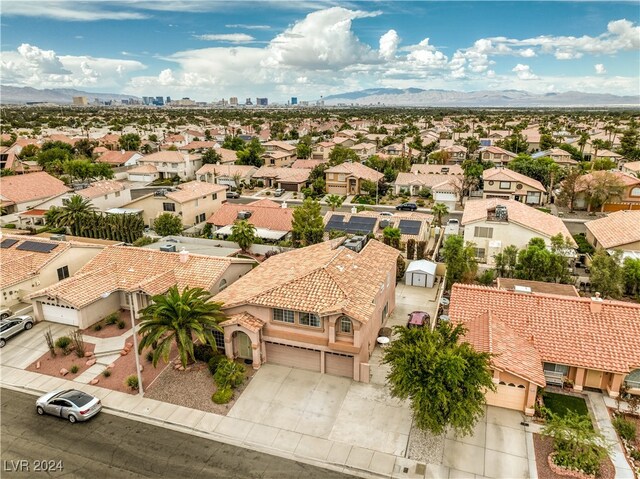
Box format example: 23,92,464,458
462,198,577,246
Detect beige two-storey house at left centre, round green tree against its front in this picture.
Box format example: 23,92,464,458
124,181,227,228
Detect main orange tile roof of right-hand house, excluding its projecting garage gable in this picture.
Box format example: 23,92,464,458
449,284,640,373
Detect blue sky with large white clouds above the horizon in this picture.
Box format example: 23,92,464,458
0,0,640,103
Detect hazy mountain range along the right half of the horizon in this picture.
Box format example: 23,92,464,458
324,88,640,107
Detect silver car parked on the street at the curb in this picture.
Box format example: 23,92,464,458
36,389,102,423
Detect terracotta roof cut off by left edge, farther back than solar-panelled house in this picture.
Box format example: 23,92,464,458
0,171,70,204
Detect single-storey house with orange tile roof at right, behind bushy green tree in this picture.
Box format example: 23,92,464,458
449,283,640,415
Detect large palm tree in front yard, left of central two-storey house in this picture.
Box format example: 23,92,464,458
138,286,226,367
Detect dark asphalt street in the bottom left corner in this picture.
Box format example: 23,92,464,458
0,389,352,479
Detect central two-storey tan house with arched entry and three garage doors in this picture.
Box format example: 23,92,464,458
213,238,399,383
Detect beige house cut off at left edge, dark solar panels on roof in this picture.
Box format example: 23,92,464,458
0,234,104,307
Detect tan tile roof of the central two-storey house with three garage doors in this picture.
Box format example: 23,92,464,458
214,242,399,323
